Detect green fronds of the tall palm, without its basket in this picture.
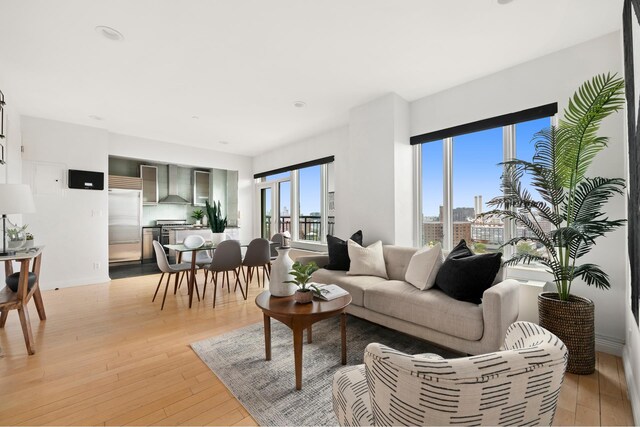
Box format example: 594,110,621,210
483,74,625,300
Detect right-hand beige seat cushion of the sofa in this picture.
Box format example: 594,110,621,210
364,280,484,341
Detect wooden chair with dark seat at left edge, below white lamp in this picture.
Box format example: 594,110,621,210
0,252,47,354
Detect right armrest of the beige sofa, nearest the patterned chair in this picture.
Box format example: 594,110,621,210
482,279,520,352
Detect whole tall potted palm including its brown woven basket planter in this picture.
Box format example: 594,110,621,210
483,74,625,374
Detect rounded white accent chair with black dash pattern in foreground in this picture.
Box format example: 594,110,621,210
333,322,568,426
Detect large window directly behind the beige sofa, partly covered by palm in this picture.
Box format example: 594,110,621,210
412,108,552,255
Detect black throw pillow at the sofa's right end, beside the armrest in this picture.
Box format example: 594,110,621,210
436,240,502,304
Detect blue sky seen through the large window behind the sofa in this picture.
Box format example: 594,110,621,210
422,118,550,216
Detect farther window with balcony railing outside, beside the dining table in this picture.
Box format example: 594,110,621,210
256,157,335,243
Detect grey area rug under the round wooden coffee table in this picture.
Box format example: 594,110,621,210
191,316,460,426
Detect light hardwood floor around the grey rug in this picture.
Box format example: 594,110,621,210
0,275,633,425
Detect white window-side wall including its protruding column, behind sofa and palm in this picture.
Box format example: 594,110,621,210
253,32,627,353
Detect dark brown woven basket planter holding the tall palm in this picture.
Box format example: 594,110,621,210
538,292,596,375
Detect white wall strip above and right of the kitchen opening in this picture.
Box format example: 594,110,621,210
108,133,254,240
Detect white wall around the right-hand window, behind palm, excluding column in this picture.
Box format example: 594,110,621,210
411,32,627,353
